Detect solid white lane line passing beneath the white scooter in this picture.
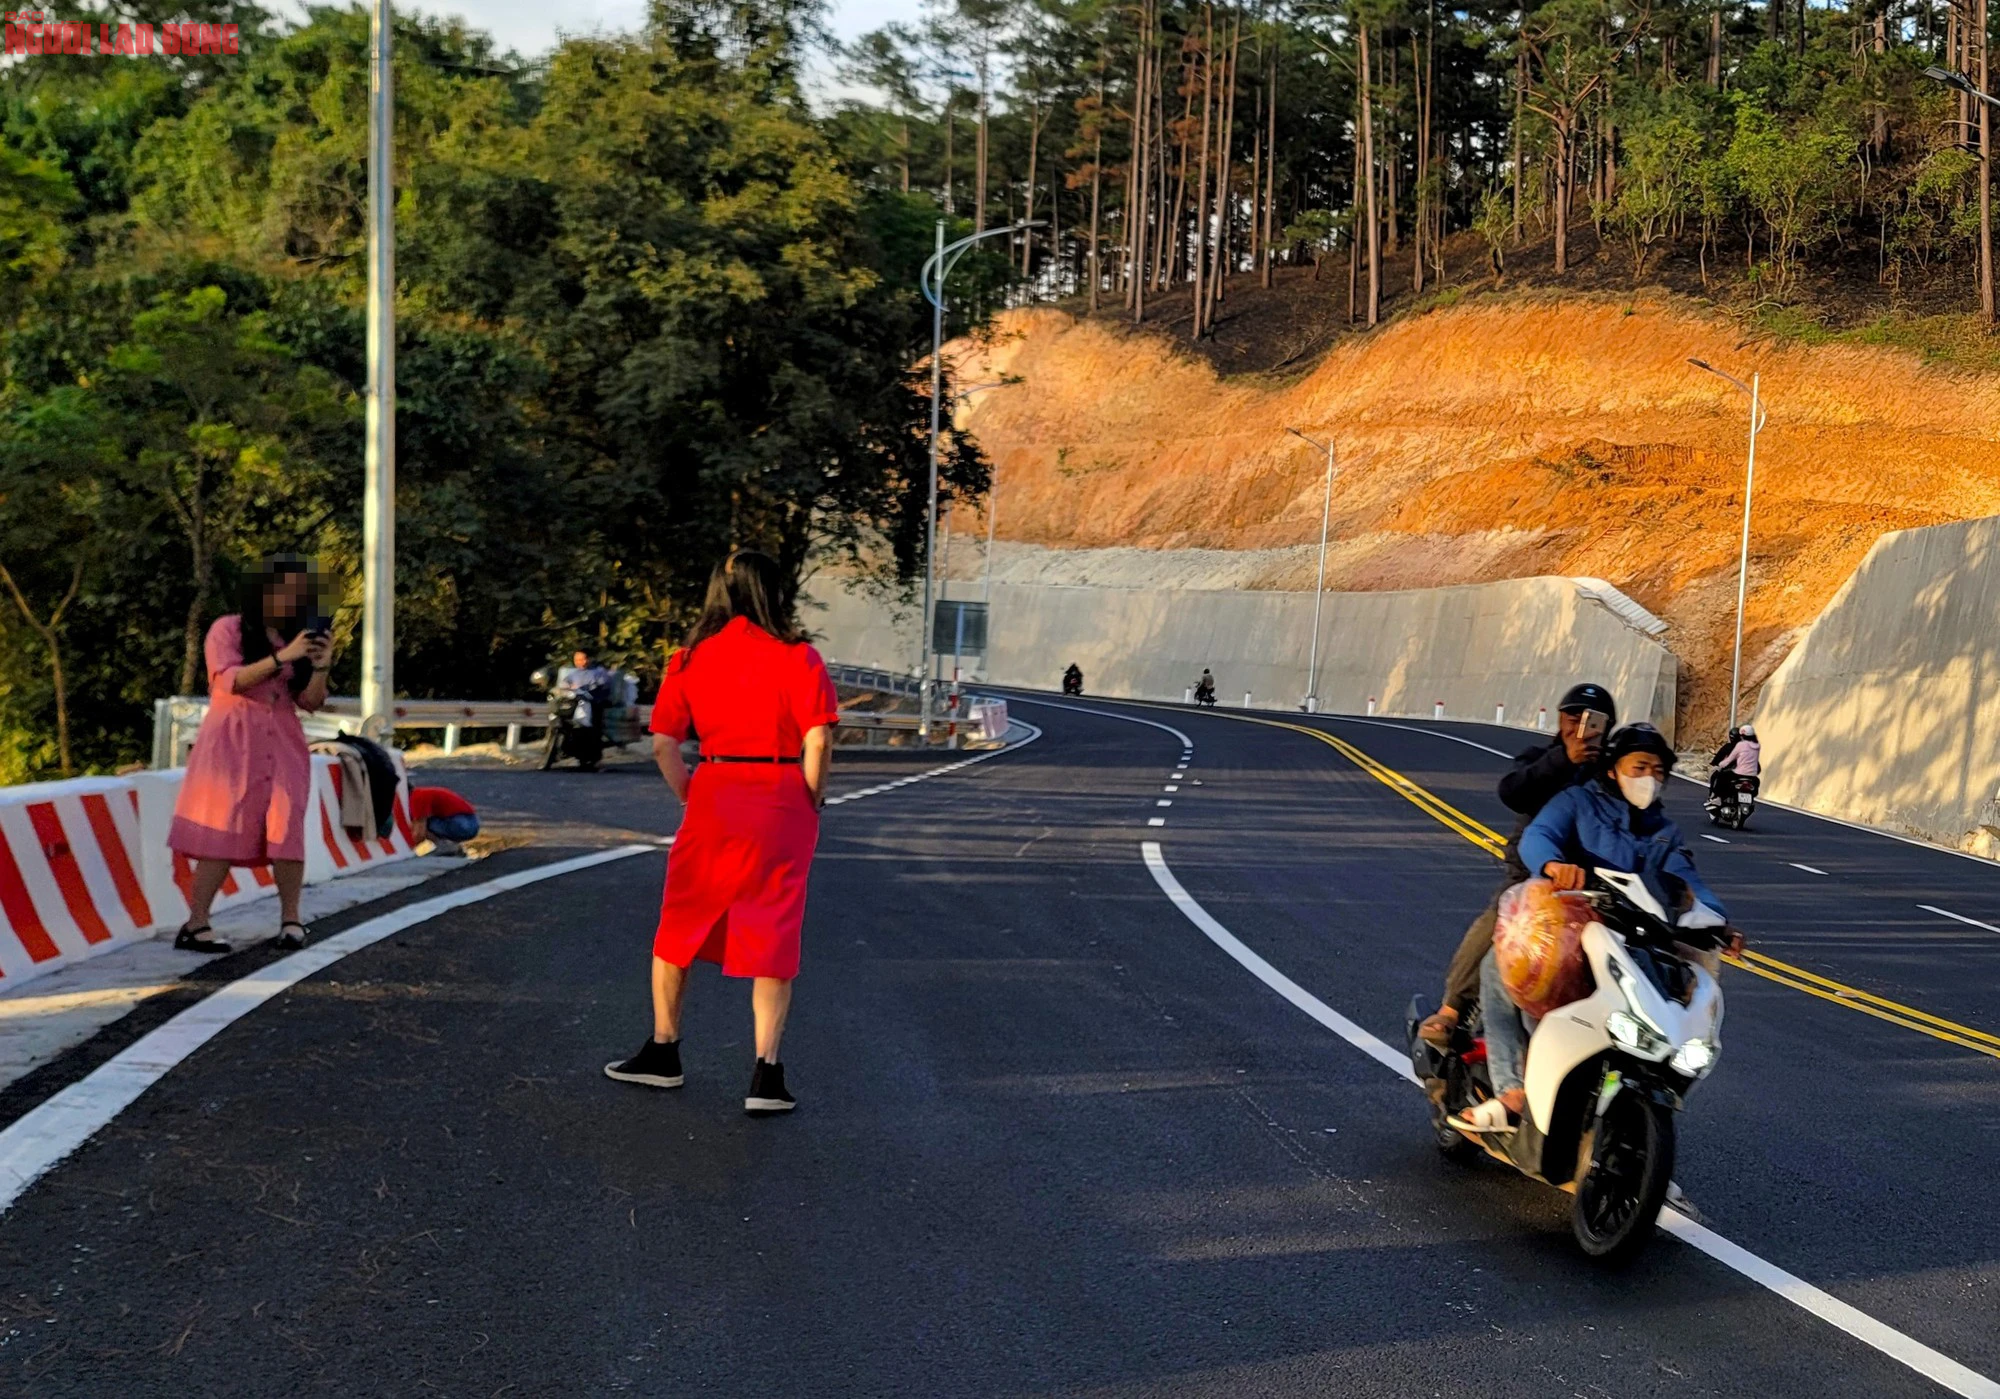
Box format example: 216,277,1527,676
1140,841,2000,1399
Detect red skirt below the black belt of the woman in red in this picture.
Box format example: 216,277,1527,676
652,763,820,981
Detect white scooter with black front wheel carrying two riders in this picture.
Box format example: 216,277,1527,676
1408,869,1726,1259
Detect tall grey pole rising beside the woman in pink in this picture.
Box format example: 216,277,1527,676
362,0,396,741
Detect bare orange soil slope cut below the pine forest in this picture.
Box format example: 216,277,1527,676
956,300,2000,739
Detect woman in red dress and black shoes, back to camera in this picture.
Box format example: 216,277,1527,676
604,550,840,1115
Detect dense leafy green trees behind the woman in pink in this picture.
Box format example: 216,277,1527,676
0,4,986,781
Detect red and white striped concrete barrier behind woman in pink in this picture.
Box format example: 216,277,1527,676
0,753,416,991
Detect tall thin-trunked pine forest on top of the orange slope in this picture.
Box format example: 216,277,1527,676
838,0,2000,317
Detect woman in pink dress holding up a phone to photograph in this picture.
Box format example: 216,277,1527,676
166,558,332,951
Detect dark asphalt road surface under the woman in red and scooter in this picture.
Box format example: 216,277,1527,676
0,701,2000,1397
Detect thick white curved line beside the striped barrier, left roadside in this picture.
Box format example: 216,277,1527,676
0,843,660,1213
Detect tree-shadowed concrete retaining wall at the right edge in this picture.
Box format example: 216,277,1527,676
1754,507,2000,853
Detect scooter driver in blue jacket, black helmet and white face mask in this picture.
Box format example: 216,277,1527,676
1452,723,1742,1131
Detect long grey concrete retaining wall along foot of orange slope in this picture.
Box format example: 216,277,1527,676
802,578,1676,735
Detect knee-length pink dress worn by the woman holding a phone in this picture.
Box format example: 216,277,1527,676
166,614,312,865
